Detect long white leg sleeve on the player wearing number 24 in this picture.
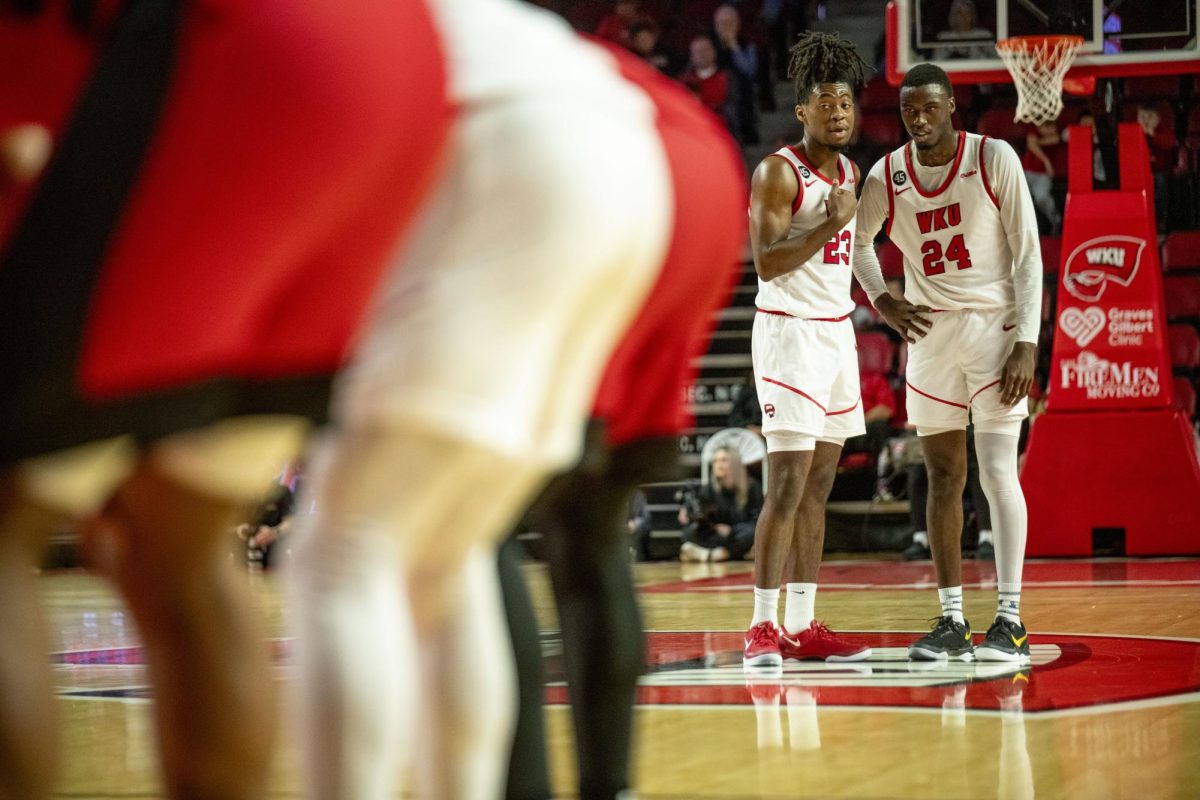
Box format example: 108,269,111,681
974,429,1028,591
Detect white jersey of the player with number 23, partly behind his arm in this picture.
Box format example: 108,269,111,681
755,148,854,319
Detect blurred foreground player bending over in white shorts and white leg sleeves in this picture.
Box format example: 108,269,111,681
285,0,673,800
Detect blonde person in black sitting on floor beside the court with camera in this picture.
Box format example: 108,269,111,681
679,447,762,561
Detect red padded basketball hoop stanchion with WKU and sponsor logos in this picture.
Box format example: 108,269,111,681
1021,124,1200,555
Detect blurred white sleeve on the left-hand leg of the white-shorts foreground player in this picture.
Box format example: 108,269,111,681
289,516,416,800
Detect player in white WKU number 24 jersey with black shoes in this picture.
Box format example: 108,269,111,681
854,64,1042,663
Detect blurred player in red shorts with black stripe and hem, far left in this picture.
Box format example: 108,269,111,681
0,0,450,799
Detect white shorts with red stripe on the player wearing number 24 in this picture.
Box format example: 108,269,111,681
905,308,1030,429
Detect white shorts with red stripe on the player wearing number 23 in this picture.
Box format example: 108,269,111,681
751,309,866,439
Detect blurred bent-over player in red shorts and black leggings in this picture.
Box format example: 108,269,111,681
500,40,745,800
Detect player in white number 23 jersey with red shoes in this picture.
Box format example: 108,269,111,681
743,34,871,667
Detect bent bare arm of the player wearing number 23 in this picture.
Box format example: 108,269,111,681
750,157,854,281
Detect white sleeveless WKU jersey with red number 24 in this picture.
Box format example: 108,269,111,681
884,131,1014,311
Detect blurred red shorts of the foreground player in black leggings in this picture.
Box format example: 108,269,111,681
594,48,746,445
